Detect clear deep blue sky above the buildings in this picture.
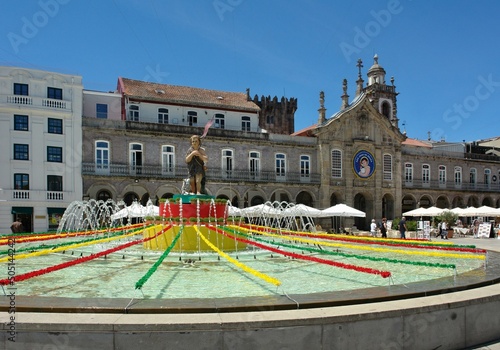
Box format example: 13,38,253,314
0,0,500,142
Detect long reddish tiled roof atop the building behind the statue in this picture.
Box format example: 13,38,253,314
118,78,260,113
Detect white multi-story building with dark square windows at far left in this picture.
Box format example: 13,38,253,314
0,67,83,232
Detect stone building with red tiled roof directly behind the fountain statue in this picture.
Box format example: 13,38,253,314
83,78,312,211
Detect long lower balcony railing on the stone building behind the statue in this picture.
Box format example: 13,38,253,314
82,163,320,184
